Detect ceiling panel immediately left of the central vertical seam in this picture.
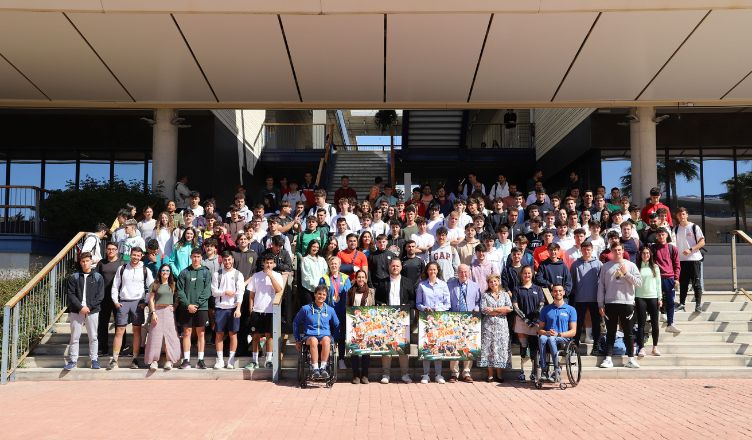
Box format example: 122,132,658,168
282,15,384,103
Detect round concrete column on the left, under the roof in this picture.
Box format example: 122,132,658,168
151,109,178,199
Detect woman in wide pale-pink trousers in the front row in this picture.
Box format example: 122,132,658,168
144,264,180,371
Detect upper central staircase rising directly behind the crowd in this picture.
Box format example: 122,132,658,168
327,150,389,202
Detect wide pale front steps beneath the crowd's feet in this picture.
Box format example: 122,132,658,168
10,291,752,381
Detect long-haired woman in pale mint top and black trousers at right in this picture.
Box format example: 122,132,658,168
635,246,662,358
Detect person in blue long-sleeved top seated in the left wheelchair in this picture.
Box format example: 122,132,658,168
293,284,340,380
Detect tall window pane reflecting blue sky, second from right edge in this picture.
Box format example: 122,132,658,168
704,158,737,243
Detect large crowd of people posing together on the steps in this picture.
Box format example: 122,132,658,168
65,171,705,383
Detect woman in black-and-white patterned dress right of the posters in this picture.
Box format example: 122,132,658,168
478,273,512,382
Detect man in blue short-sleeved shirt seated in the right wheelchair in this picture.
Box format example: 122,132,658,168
535,284,577,383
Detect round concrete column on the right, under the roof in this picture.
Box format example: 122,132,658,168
629,107,658,206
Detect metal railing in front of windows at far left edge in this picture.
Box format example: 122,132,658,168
0,186,49,235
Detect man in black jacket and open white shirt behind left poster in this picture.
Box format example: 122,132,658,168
375,258,415,384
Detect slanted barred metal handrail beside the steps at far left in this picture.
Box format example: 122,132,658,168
0,232,86,384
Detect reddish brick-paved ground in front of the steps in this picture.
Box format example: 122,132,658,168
0,379,752,440
